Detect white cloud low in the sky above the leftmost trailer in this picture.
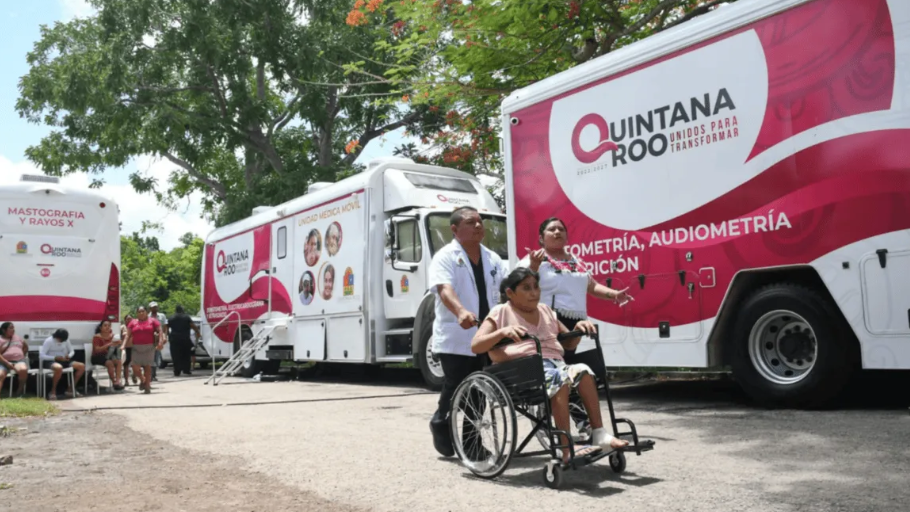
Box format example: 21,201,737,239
0,155,214,251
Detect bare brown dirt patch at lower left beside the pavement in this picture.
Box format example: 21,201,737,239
0,413,357,512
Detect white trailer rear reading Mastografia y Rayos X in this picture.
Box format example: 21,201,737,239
0,175,120,355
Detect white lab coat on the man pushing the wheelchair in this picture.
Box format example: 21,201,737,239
428,240,509,356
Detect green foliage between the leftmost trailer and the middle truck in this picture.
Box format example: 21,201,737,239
120,233,205,317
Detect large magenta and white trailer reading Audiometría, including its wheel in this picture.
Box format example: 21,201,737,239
502,0,910,405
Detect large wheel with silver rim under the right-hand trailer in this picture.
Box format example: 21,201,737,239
731,284,854,407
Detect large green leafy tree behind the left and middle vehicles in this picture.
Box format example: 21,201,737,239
16,0,428,224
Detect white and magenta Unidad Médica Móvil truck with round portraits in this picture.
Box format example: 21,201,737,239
202,158,507,387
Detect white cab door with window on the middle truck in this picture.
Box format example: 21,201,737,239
382,214,428,319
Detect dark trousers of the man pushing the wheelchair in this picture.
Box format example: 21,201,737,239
433,354,488,460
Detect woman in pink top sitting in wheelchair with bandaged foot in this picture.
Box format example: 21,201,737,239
471,267,629,461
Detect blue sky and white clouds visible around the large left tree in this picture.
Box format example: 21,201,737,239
0,0,412,249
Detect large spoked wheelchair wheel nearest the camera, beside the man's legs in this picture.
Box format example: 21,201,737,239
449,372,516,478
